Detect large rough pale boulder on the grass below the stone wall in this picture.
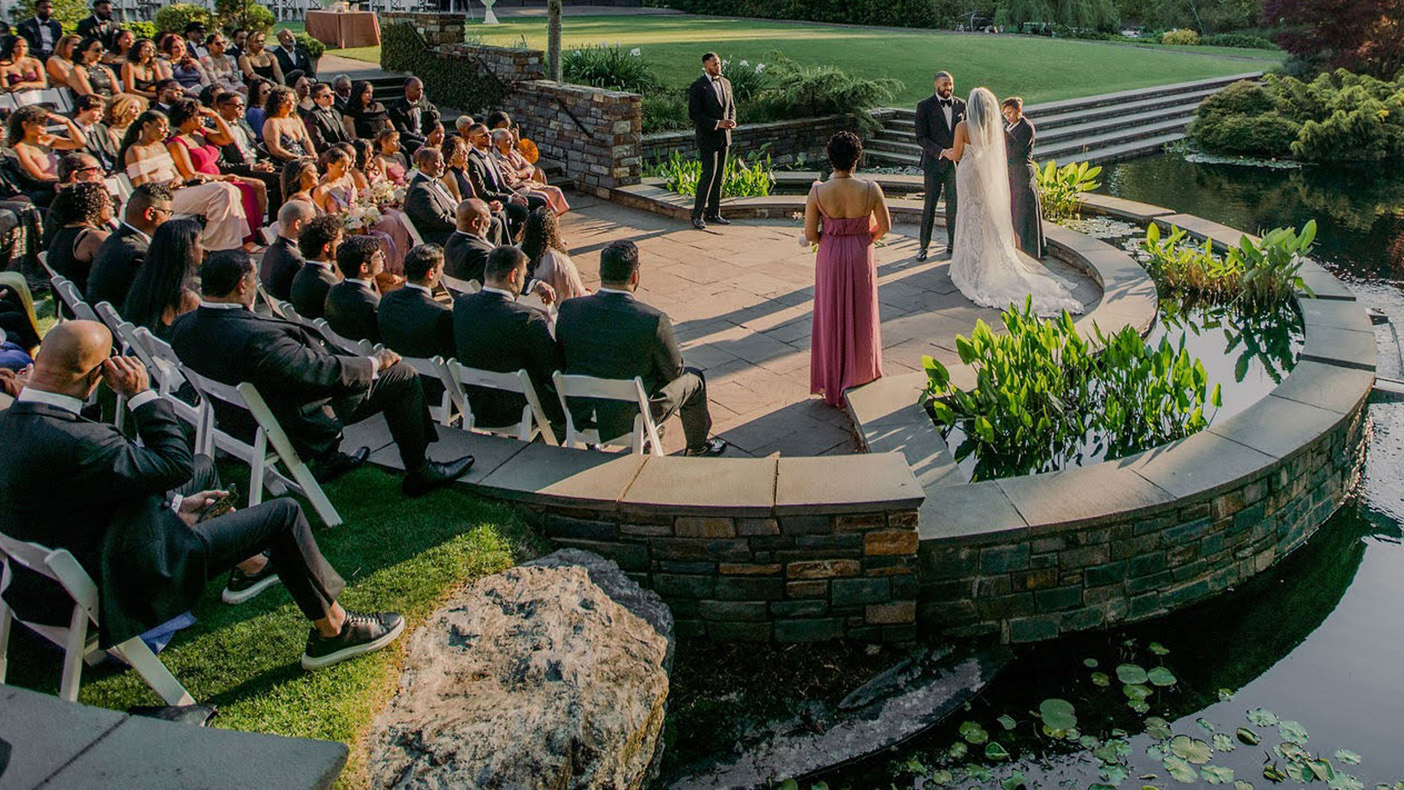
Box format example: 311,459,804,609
369,549,673,789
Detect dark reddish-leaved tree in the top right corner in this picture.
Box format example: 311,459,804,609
1262,0,1404,80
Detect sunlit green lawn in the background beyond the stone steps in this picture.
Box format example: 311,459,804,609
337,15,1283,106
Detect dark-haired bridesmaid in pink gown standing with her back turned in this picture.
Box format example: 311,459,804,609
804,132,892,408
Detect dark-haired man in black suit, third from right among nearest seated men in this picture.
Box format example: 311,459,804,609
376,244,453,362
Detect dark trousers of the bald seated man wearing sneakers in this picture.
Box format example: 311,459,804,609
177,456,345,620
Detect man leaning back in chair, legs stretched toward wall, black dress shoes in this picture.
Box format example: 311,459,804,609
171,249,473,497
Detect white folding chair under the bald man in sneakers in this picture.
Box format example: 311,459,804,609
0,533,195,704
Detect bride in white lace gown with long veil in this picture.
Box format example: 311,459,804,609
941,88,1082,316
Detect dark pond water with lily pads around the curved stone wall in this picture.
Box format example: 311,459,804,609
827,154,1404,787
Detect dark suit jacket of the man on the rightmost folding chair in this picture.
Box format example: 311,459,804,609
556,290,682,438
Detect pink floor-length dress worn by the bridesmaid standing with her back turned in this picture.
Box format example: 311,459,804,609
809,206,882,407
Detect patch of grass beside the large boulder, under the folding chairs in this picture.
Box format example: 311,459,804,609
8,454,541,787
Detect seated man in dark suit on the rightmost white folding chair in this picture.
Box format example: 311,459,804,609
556,240,726,456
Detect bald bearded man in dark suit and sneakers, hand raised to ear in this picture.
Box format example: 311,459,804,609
0,321,404,669
